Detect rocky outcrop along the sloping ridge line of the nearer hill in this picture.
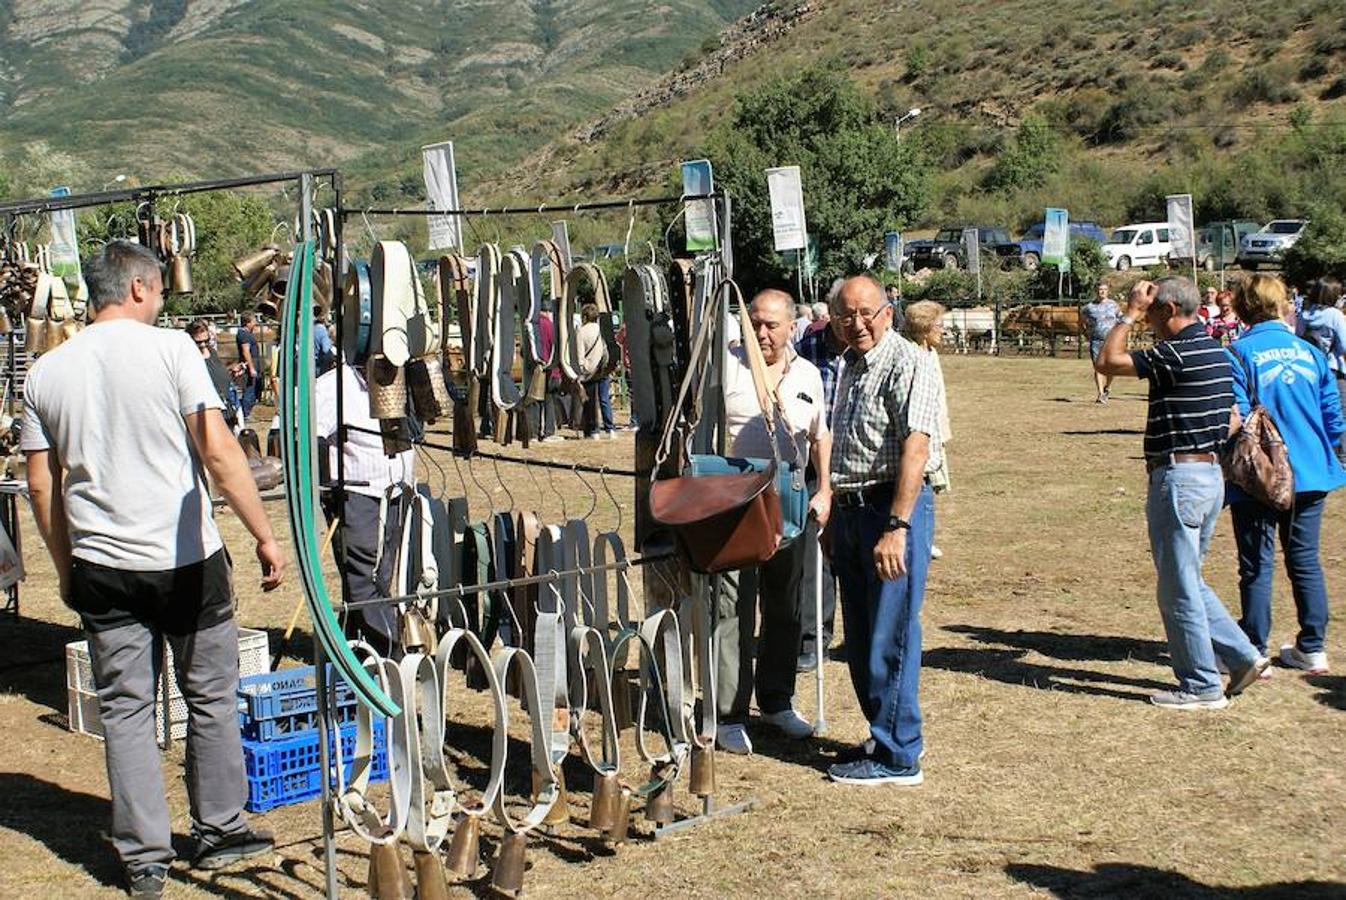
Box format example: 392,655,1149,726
575,0,818,144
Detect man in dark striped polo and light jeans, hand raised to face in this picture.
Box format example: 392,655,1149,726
1094,277,1271,709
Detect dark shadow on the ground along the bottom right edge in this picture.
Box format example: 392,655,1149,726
1005,862,1346,900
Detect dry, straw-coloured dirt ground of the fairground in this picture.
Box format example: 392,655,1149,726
0,357,1346,897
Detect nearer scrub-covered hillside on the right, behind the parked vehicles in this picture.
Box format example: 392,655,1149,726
475,0,1346,235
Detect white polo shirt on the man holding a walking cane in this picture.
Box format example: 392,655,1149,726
724,341,829,465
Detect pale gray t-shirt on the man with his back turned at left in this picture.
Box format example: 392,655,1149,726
23,319,223,572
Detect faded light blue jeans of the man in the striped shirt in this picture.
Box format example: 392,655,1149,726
1145,463,1257,698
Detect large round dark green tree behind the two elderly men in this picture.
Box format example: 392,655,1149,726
711,67,929,291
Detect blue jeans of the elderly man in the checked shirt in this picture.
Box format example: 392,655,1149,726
830,486,934,767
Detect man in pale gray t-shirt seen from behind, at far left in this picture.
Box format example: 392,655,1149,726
22,241,284,897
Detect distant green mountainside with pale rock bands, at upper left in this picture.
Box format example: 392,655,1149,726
0,0,755,194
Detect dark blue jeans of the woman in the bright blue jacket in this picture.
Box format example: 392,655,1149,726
1229,491,1327,654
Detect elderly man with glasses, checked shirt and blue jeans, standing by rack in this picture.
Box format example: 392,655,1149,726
828,276,940,786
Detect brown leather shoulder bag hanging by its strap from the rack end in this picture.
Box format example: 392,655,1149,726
650,278,782,573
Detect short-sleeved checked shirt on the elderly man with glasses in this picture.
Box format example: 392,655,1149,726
832,330,942,491
